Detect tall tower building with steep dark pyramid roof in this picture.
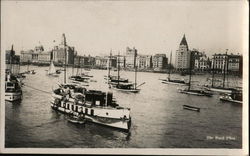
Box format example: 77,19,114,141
175,34,191,71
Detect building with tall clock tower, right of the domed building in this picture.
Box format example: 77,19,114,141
52,34,75,65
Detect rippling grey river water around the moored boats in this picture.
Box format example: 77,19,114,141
5,66,242,148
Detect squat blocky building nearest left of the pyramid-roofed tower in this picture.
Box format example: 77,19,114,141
152,54,168,70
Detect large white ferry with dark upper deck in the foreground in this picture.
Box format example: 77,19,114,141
51,85,131,132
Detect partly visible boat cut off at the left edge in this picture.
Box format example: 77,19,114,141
5,74,22,102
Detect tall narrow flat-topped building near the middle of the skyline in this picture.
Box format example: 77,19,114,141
125,47,137,68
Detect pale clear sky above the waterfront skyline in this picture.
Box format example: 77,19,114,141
1,0,248,59
